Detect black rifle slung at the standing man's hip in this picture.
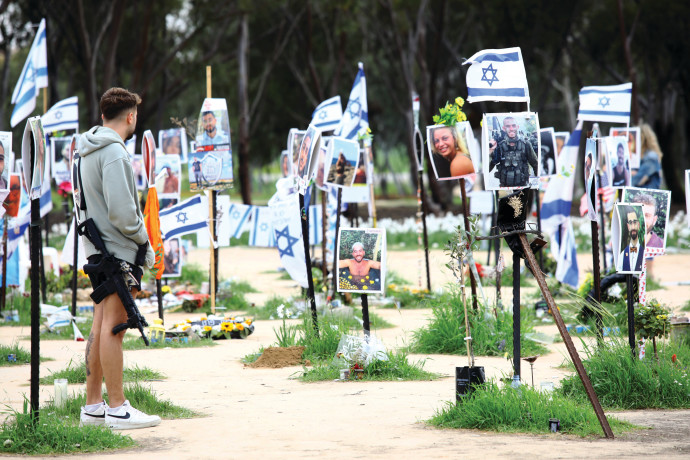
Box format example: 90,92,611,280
77,219,149,346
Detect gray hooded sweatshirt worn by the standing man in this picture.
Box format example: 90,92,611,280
79,126,154,266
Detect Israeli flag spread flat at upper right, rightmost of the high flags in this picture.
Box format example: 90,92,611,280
577,83,632,124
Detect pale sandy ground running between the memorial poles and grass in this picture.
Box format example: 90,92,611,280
0,248,690,459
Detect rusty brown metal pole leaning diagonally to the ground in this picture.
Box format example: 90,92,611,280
520,234,614,439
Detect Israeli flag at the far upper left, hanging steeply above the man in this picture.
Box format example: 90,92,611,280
10,19,48,128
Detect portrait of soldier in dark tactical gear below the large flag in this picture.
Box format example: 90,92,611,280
482,112,541,190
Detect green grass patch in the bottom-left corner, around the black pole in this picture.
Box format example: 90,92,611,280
0,408,136,455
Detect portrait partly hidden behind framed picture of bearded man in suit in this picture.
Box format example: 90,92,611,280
621,187,671,255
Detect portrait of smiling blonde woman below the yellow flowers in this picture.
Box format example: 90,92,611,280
426,121,475,180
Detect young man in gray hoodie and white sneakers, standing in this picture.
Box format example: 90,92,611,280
79,88,161,429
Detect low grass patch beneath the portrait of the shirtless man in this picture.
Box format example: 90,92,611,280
299,352,439,382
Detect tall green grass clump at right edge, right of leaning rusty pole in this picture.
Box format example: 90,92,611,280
561,338,690,409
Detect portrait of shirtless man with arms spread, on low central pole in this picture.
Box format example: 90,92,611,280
337,228,386,294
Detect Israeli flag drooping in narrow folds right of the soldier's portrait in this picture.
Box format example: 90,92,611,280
541,120,582,233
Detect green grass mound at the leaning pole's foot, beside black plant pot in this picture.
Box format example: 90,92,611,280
428,382,635,437
